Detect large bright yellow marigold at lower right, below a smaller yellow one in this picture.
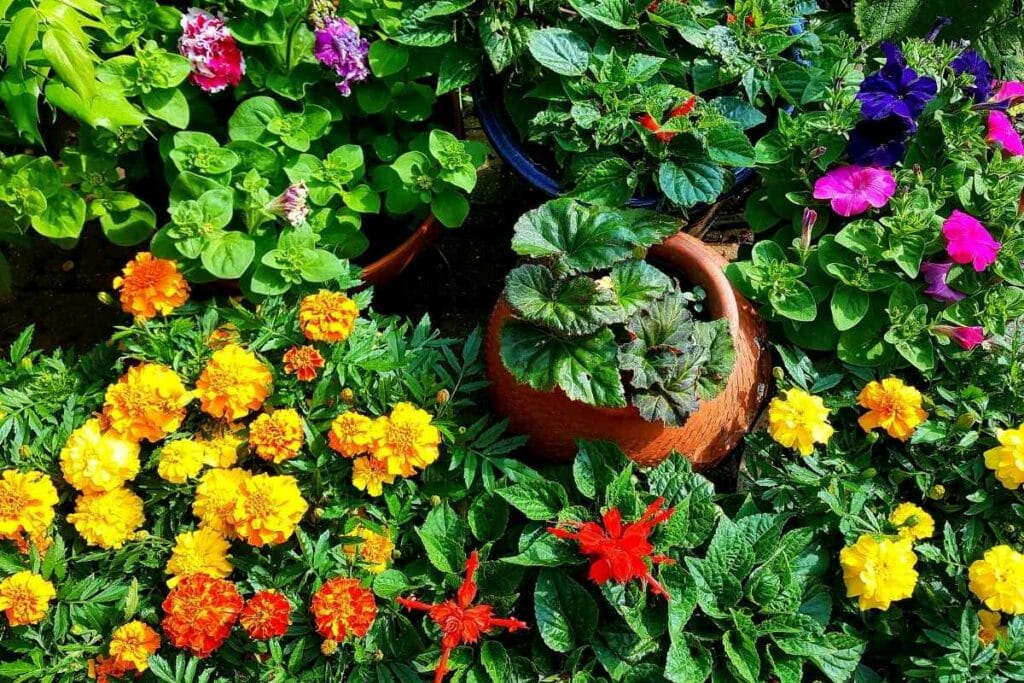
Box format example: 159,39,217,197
839,533,918,611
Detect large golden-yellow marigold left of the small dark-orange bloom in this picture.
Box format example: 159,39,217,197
196,344,273,420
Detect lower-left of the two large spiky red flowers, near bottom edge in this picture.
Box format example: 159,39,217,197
395,550,527,683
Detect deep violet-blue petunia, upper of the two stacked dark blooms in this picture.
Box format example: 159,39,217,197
857,43,938,121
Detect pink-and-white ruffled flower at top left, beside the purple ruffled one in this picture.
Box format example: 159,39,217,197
178,7,246,92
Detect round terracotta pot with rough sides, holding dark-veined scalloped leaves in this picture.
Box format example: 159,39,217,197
485,232,771,469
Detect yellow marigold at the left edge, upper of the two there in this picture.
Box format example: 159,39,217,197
0,470,57,552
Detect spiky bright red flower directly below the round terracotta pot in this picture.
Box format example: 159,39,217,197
548,498,676,599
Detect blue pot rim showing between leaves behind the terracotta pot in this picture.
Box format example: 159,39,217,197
473,17,807,210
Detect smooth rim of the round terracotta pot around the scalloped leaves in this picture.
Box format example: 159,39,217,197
493,231,740,424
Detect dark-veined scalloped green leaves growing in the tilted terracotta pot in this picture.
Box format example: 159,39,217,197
501,199,734,425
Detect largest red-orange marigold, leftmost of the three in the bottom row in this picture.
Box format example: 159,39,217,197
162,573,242,658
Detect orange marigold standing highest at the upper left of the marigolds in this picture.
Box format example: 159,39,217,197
114,252,188,319
